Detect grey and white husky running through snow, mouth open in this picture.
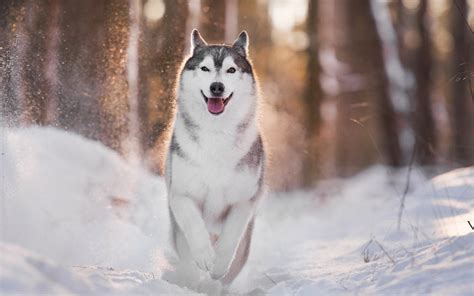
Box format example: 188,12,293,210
166,30,265,289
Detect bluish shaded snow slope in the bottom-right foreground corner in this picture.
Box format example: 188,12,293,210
268,233,474,295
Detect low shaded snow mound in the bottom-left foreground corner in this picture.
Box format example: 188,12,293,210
0,243,195,295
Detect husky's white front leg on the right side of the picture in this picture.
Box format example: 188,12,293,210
211,201,254,279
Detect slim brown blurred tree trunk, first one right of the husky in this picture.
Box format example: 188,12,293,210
302,1,323,187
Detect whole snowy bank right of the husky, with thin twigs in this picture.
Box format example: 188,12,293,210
239,167,474,295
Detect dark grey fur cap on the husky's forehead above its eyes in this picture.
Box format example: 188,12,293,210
184,45,253,76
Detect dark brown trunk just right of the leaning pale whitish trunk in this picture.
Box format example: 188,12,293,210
413,0,436,165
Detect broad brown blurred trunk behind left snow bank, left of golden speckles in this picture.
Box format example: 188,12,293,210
54,0,105,140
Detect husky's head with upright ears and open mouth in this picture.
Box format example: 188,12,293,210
180,30,255,117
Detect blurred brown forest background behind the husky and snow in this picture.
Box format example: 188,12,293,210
0,0,474,190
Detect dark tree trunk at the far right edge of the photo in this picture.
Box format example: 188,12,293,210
449,0,474,166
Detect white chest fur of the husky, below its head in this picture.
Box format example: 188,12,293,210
172,115,258,197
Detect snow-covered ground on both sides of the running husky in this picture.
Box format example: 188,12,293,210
0,127,474,295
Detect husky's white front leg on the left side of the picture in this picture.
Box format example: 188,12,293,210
169,196,215,271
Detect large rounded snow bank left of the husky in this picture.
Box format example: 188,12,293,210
0,127,169,272
